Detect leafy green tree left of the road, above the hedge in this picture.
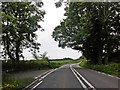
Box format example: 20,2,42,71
2,2,45,61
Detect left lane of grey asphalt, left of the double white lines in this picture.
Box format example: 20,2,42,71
37,65,82,88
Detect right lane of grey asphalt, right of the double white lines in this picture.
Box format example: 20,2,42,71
73,64,120,90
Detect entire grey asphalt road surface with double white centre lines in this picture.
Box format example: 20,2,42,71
24,64,120,90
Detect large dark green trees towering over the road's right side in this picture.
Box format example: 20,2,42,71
52,2,120,64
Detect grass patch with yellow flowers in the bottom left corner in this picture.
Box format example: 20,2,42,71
2,73,34,90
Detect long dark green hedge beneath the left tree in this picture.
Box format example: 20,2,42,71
2,60,50,72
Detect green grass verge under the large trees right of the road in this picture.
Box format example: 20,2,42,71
80,59,120,77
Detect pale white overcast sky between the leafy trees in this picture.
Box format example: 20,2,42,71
23,0,81,60
